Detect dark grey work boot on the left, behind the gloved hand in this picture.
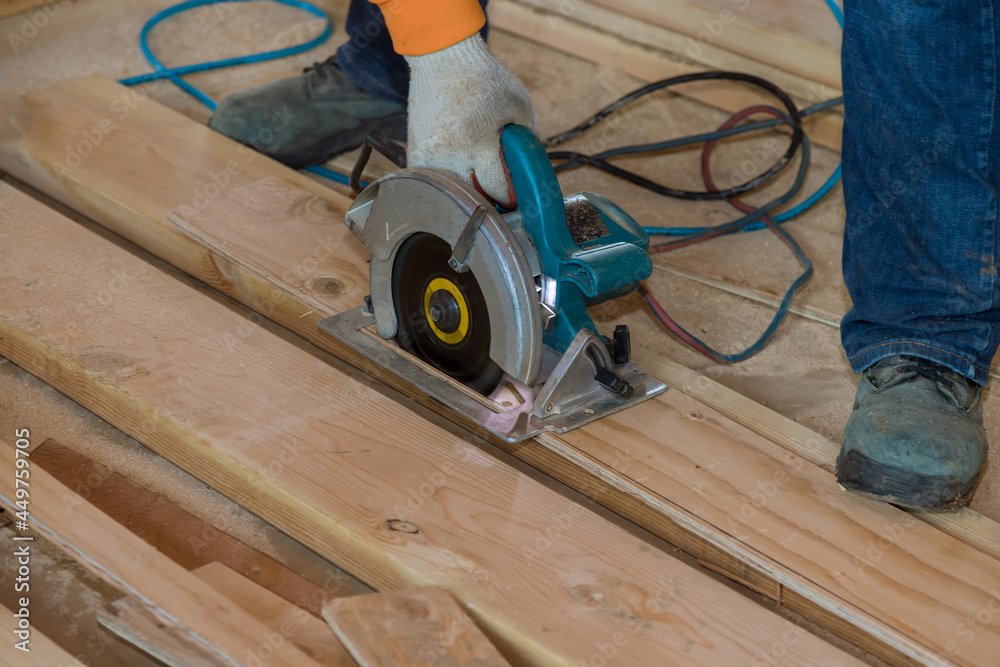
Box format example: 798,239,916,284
208,56,406,169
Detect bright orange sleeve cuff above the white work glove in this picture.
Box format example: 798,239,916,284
371,0,486,56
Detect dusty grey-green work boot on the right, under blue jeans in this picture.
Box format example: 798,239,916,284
837,356,988,509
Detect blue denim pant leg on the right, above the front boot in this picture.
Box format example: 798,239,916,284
841,0,1000,385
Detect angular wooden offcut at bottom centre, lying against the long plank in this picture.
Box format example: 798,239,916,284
323,586,508,667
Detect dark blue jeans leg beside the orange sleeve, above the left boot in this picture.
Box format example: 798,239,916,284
337,0,489,104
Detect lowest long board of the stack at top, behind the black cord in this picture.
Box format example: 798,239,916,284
490,0,843,151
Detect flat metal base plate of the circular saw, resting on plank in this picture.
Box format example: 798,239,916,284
319,307,667,443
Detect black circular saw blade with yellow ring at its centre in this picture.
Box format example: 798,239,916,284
392,232,504,395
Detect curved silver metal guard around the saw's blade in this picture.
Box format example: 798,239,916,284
344,168,543,386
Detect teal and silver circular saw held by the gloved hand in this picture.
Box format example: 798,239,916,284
320,125,666,442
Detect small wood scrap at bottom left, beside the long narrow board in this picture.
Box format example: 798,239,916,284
97,596,226,667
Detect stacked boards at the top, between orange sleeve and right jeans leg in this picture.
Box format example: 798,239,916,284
490,0,844,150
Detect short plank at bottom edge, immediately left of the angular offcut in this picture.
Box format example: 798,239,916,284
193,563,358,667
